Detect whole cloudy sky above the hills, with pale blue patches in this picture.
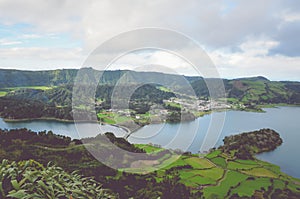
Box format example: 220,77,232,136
0,0,300,81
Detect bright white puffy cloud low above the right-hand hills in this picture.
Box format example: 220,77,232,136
209,37,300,81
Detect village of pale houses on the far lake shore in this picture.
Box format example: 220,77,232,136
98,98,234,126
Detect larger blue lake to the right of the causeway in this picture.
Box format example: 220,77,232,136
129,107,300,178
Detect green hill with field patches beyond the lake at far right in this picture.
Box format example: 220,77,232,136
191,77,300,105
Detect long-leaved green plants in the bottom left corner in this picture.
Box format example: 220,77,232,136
0,160,115,199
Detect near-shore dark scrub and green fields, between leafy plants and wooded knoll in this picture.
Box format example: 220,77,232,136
0,129,300,198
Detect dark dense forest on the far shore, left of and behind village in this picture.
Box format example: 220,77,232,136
0,82,174,121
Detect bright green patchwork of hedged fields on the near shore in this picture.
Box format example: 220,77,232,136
135,144,300,198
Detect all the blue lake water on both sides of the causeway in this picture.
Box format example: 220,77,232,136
0,107,300,178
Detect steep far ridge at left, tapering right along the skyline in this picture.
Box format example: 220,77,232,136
0,68,201,88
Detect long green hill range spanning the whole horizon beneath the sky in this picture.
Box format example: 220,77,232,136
0,68,300,110
